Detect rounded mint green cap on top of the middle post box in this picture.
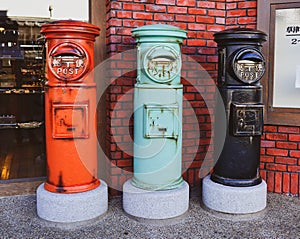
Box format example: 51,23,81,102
132,24,187,43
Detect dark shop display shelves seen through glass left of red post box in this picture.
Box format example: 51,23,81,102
0,13,46,182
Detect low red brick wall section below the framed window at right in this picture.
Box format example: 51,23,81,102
260,125,300,195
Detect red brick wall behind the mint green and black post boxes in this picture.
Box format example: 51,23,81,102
101,0,300,195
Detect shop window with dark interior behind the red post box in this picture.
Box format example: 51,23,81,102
0,0,106,183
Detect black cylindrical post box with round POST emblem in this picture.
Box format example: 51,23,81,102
211,28,266,187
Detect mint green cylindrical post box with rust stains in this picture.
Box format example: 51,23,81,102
132,24,186,190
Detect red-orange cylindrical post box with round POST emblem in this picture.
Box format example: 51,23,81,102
41,20,100,193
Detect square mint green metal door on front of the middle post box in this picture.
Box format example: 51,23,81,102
144,104,179,139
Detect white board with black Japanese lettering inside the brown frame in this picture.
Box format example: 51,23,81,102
273,8,300,108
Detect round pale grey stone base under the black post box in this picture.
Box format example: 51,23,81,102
202,176,267,214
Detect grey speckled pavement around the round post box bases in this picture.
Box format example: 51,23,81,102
0,192,300,239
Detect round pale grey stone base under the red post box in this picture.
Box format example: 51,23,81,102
36,180,108,223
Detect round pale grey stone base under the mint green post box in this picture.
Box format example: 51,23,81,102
123,179,189,219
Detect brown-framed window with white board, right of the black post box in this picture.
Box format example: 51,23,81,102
257,0,300,125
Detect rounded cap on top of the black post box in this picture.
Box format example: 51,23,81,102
214,28,267,43
